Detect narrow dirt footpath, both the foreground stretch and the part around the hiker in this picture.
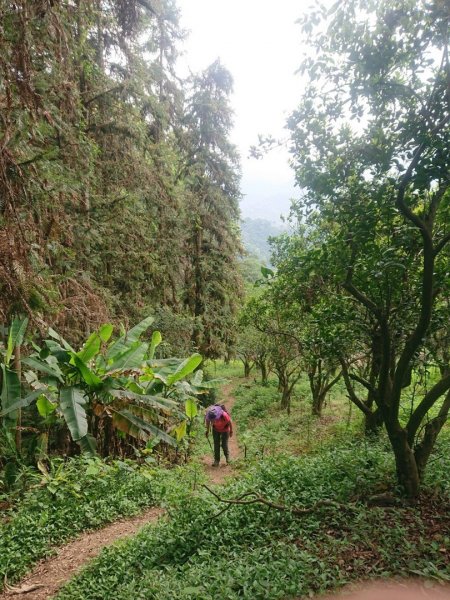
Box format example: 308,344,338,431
0,383,239,600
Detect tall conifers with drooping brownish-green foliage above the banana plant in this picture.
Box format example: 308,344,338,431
0,0,240,355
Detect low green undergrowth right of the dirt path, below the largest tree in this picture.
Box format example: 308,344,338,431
58,439,450,600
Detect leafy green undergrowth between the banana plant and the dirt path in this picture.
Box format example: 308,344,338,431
0,457,201,583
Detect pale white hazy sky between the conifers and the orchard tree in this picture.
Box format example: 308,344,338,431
178,0,305,220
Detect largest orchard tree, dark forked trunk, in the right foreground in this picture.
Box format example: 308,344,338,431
289,0,450,498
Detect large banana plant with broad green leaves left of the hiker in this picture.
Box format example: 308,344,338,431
0,317,206,453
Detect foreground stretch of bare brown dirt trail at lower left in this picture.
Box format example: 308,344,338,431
0,508,164,600
